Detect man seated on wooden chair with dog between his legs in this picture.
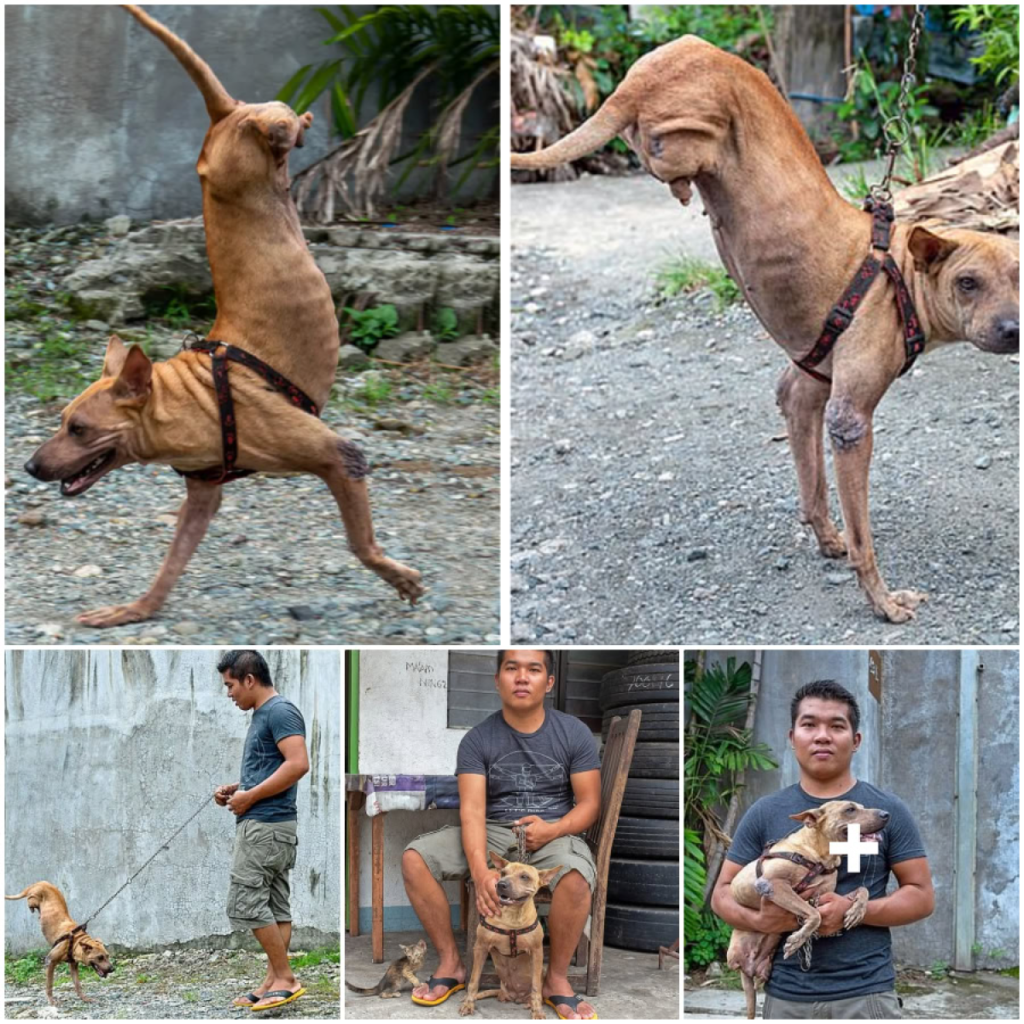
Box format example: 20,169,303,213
401,650,601,1020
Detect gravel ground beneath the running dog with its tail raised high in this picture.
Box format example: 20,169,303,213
5,223,501,644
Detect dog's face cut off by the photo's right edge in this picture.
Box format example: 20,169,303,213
907,227,1020,353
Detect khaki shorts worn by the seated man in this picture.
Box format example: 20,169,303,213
406,821,597,892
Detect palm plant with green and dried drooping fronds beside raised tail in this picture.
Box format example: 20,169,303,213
276,4,501,216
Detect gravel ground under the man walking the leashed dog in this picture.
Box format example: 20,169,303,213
4,949,341,1020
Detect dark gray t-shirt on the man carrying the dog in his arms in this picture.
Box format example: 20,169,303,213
726,779,926,1002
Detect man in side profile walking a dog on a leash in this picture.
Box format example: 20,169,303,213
214,650,309,1011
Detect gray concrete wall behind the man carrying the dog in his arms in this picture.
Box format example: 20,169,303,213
707,648,1020,968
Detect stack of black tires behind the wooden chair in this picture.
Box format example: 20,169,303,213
601,650,679,952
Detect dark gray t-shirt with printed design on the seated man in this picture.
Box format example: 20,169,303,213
456,709,601,823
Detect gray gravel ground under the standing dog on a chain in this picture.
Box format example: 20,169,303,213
510,177,1019,644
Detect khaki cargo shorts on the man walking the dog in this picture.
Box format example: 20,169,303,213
227,818,299,929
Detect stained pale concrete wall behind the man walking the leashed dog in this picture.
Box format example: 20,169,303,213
4,649,344,953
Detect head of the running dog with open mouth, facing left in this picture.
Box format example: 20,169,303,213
25,335,153,498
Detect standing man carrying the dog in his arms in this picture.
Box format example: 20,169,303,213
712,680,935,1020
